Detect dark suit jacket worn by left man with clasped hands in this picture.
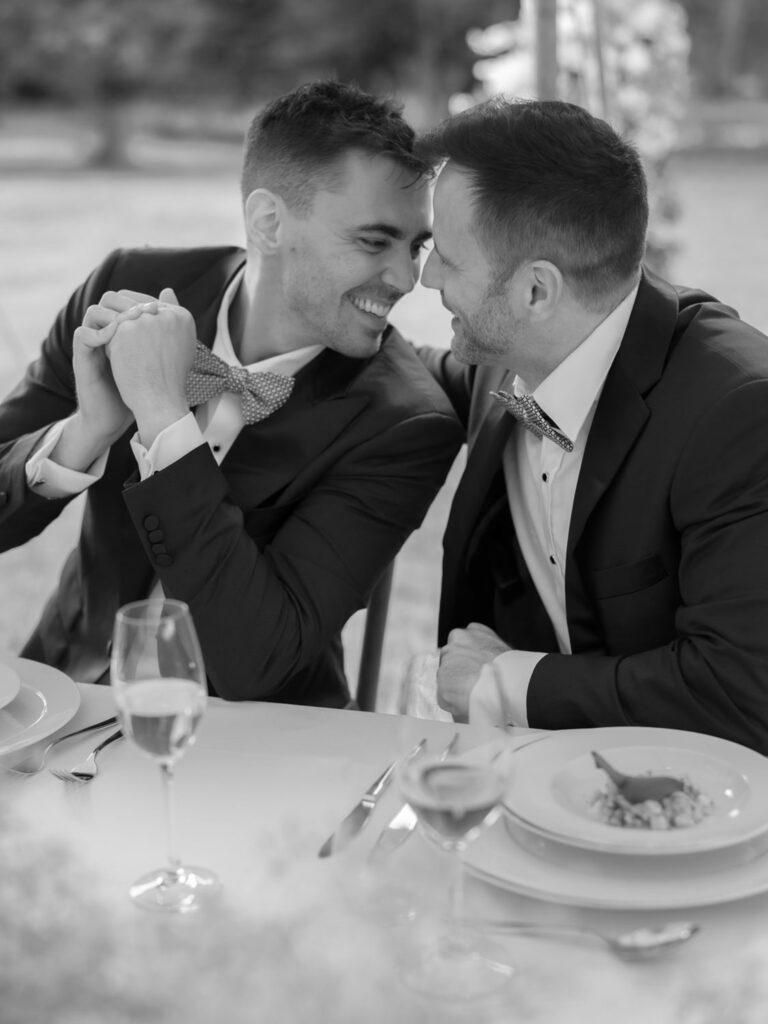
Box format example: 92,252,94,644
0,248,462,707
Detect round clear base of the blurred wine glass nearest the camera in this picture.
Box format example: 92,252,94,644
402,934,515,1000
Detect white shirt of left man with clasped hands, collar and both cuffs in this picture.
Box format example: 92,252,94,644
26,270,323,498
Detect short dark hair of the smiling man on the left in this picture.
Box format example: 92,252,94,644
241,80,432,215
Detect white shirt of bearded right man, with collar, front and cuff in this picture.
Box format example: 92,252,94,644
469,286,637,726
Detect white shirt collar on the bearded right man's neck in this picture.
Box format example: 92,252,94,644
520,282,640,441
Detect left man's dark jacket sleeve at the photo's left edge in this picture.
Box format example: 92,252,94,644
0,251,119,551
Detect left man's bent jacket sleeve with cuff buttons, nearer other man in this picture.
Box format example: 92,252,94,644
125,412,462,699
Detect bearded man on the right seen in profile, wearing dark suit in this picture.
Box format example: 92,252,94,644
421,99,768,753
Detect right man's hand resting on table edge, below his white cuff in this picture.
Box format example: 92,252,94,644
437,623,511,722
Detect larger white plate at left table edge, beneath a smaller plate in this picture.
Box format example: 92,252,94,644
0,657,80,755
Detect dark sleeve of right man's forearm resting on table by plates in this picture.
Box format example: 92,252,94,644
527,381,768,753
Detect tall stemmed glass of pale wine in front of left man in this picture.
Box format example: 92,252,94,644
111,598,219,913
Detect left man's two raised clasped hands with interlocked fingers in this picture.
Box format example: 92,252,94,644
73,288,197,446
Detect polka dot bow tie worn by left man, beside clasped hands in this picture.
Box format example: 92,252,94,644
186,342,294,424
